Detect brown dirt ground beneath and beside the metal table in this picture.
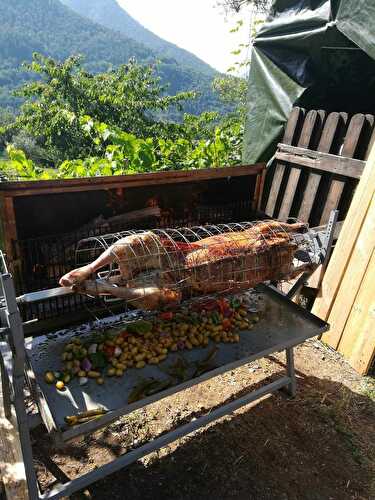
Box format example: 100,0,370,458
34,341,375,500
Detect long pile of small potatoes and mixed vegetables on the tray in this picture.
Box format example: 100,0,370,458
45,297,259,390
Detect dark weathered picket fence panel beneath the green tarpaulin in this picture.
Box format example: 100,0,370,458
260,107,375,227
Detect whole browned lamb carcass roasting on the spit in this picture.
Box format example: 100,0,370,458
60,221,305,309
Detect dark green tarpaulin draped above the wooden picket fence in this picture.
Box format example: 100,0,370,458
244,0,375,163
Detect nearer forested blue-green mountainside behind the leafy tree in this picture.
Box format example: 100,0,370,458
0,0,222,112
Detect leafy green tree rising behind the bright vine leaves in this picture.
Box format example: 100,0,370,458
11,54,194,164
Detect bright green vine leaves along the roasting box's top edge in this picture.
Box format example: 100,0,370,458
0,116,242,180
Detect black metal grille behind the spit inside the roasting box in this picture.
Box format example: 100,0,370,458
14,200,252,324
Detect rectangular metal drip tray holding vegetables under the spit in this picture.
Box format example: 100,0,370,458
26,286,327,440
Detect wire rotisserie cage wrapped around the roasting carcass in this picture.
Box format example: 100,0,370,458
76,220,316,309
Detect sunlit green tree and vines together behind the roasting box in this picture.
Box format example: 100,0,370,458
0,54,246,179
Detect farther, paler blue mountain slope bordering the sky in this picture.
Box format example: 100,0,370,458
61,0,215,76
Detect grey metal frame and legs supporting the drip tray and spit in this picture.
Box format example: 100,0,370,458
0,257,328,500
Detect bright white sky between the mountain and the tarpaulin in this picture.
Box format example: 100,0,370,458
117,0,253,72
